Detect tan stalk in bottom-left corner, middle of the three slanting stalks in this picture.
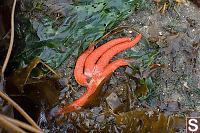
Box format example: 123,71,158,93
0,114,44,133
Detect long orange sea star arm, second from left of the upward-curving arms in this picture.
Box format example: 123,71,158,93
84,37,131,76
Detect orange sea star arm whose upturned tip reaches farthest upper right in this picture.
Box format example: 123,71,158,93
95,34,141,71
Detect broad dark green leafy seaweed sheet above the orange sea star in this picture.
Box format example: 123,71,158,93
14,0,145,68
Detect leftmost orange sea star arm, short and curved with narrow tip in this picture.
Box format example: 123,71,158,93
74,42,95,86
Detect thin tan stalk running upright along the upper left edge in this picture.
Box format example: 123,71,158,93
0,0,16,75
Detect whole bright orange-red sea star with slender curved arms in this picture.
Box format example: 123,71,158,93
57,34,141,114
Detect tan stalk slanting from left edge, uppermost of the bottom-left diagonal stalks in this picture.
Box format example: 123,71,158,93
0,91,41,130
